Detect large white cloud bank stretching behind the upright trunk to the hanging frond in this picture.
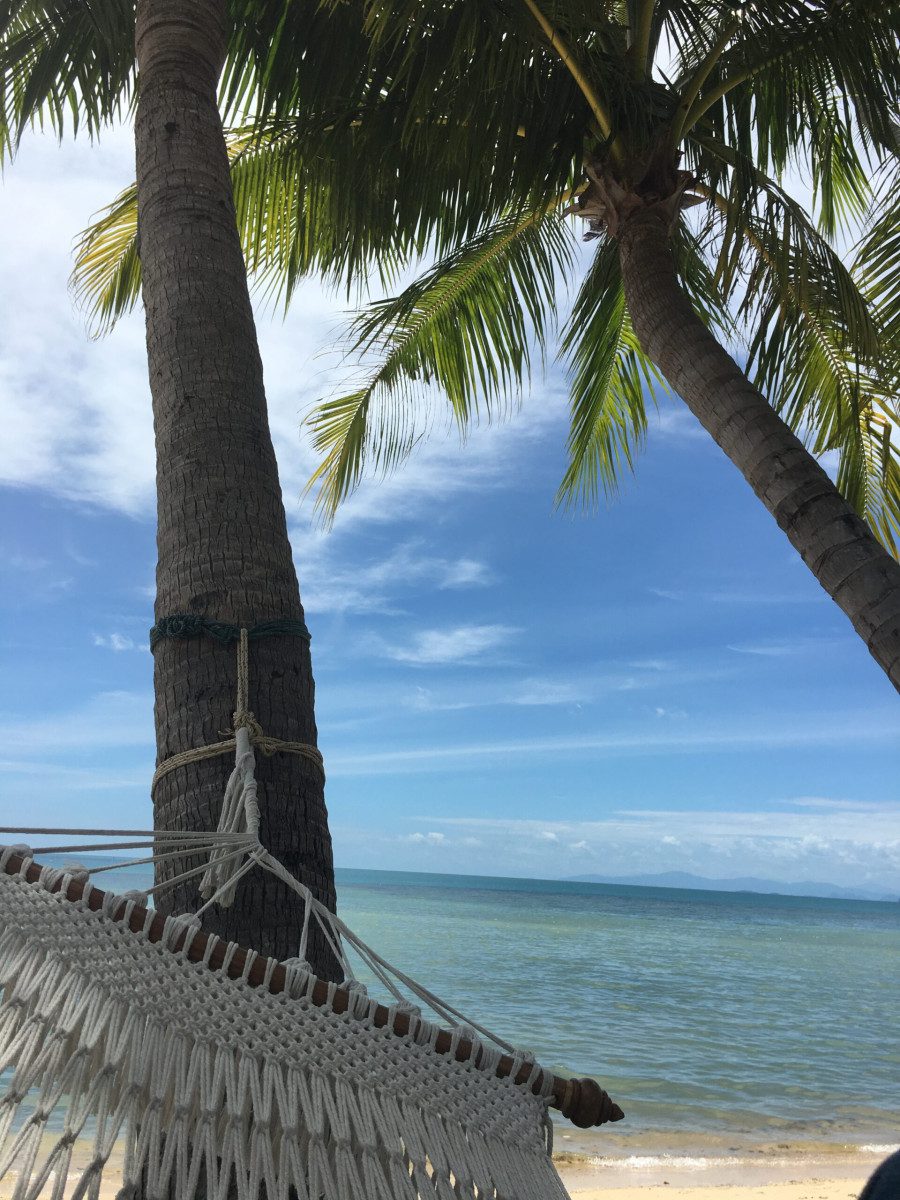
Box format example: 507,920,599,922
0,128,565,530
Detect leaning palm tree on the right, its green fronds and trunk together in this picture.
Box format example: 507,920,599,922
72,0,900,688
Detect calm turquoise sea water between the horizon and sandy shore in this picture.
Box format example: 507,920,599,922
7,869,900,1154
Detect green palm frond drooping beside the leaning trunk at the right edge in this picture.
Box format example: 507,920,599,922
696,169,900,552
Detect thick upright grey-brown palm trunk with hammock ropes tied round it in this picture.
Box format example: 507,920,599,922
134,0,336,978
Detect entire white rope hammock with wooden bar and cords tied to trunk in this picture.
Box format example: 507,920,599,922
0,629,623,1200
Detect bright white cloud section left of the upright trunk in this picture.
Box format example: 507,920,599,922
0,133,154,514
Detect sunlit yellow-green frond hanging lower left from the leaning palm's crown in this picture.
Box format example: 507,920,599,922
306,212,574,518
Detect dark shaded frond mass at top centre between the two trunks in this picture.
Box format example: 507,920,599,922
223,0,609,254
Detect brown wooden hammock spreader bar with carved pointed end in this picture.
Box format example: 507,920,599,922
6,854,625,1129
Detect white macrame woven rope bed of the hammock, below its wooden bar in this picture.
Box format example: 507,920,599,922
0,851,565,1200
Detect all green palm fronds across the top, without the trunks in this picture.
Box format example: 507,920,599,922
0,0,900,551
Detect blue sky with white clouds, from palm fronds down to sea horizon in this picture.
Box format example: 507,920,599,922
0,133,900,892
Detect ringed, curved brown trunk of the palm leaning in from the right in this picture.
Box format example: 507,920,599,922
617,208,900,690
